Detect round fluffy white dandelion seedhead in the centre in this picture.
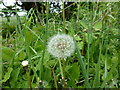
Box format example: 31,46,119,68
47,34,75,58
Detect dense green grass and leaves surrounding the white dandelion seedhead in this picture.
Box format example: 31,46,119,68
0,2,120,88
